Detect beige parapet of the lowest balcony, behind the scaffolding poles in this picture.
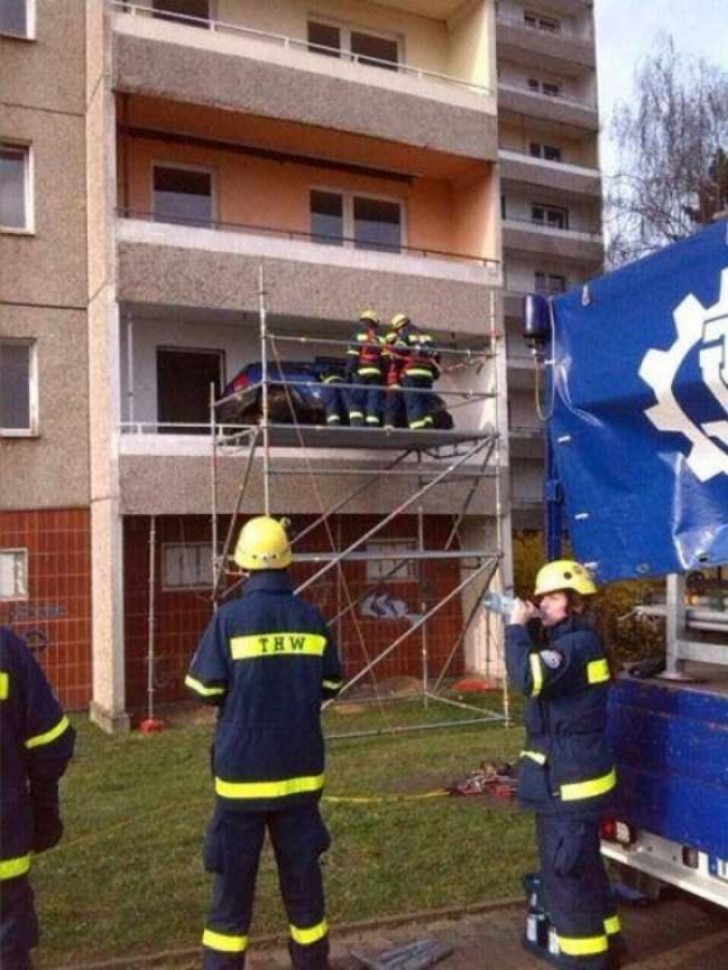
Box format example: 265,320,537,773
121,452,495,515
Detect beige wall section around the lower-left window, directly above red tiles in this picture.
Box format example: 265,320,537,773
0,306,89,509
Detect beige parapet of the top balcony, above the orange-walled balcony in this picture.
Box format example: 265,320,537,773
114,34,497,159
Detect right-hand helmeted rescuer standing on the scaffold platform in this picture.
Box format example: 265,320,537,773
384,313,440,430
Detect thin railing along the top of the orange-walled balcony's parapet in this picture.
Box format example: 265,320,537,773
116,208,499,269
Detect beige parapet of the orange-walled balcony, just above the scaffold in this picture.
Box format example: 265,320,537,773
118,243,488,334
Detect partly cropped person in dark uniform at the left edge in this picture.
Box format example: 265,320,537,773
0,627,75,970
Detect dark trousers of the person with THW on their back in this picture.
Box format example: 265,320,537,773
202,803,330,970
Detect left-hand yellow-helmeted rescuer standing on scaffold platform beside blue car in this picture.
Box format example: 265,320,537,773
346,310,383,428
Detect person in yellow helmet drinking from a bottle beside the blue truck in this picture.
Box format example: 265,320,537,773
506,560,624,970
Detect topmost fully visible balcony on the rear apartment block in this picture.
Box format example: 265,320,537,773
496,13,596,77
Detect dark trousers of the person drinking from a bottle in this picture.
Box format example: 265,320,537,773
536,811,623,970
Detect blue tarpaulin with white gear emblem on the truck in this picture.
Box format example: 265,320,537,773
549,222,728,581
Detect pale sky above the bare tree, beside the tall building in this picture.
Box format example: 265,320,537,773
594,0,728,174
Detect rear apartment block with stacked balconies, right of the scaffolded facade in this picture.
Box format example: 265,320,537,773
496,0,604,530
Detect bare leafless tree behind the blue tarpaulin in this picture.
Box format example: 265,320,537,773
606,36,728,266
